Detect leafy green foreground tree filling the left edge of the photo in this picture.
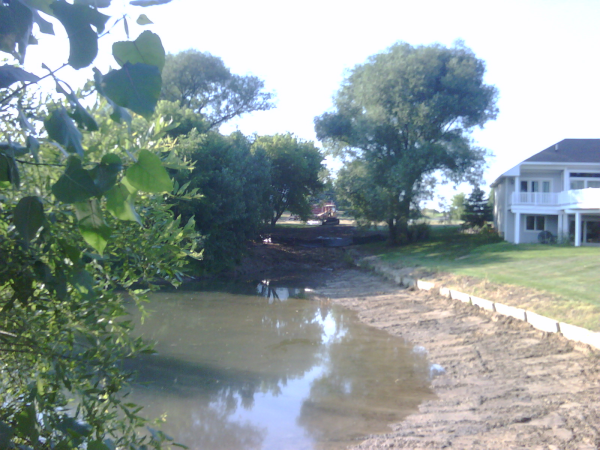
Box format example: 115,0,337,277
0,0,204,450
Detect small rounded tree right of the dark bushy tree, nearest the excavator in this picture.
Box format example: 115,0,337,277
252,133,323,227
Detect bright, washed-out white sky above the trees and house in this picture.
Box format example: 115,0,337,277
23,0,600,207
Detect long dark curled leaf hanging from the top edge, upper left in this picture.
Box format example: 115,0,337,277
50,0,109,69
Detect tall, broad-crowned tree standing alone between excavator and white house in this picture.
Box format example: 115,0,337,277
315,43,497,244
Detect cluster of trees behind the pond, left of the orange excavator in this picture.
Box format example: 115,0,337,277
156,50,324,273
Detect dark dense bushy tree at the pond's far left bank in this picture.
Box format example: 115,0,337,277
175,125,270,272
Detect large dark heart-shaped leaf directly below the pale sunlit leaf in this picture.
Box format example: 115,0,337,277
102,63,162,119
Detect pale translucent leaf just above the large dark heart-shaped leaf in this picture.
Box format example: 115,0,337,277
113,31,165,72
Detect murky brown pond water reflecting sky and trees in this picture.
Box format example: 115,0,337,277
131,285,433,450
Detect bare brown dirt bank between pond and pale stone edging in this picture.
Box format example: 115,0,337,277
318,269,600,450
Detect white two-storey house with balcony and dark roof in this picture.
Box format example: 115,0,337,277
492,139,600,246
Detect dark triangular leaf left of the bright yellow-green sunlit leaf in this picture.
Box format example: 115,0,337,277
52,156,102,203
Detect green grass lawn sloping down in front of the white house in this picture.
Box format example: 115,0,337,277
381,226,600,330
